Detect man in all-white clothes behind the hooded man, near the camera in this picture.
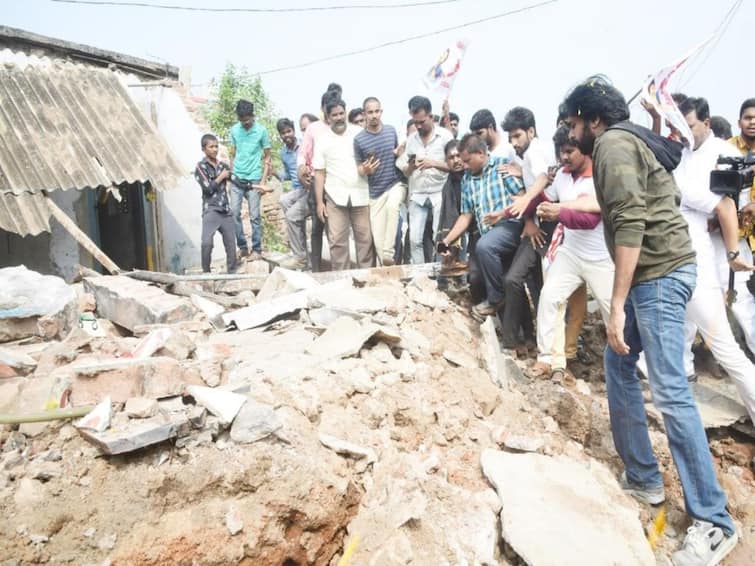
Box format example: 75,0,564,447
674,98,755,421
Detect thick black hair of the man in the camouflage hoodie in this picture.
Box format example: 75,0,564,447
563,75,629,126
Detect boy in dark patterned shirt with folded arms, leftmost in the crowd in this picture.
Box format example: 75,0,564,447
194,134,236,273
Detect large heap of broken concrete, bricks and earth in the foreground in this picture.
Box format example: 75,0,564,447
0,262,755,565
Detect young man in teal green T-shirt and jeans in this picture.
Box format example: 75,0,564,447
230,100,270,260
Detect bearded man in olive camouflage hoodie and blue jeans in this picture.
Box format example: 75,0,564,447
564,77,737,566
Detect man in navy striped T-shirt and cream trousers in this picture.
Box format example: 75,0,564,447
354,96,406,265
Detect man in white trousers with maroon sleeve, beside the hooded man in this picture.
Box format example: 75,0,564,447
533,126,614,379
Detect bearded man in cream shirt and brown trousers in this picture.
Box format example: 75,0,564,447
312,98,374,271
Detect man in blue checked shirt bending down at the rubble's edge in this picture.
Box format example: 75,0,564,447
442,134,524,320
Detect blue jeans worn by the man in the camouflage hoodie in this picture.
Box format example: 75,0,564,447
605,264,734,534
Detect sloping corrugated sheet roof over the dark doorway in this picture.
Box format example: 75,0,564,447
0,63,185,200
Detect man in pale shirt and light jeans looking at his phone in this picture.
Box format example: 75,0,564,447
402,96,453,264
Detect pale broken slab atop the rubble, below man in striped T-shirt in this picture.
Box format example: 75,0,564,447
306,316,400,358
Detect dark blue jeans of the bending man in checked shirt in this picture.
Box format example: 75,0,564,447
474,220,522,305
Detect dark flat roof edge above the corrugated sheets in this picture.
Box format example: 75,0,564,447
0,25,179,80
